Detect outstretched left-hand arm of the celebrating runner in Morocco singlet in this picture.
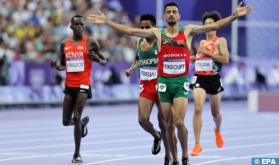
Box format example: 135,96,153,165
87,10,156,38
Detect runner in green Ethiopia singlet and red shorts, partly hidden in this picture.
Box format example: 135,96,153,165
126,14,172,165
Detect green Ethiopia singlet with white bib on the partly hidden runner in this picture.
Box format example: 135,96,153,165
137,38,158,81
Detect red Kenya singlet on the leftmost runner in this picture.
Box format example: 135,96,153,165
64,36,92,87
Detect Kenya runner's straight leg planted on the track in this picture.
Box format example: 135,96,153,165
73,93,88,155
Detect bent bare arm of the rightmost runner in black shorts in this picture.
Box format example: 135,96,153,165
199,37,229,64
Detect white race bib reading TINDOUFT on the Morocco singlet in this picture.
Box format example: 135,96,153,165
163,59,186,74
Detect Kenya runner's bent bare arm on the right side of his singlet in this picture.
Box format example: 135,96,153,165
86,38,107,66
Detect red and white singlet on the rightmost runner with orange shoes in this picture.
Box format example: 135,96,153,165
195,37,223,76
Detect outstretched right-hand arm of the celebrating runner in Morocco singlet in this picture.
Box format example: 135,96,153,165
184,2,253,35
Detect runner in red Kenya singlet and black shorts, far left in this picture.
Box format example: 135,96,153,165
50,15,106,163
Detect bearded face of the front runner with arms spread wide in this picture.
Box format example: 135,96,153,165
164,6,181,25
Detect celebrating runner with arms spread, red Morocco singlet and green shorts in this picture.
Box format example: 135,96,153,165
87,2,253,165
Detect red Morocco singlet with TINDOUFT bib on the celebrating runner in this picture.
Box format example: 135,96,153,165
158,27,191,77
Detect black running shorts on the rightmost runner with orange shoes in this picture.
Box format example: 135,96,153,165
190,74,224,95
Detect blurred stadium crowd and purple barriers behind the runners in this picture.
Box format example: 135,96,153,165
0,0,279,108
